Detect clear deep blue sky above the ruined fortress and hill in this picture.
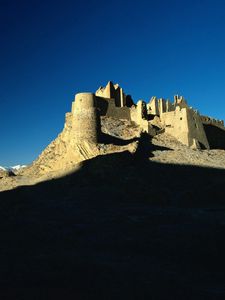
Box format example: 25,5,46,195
0,0,225,166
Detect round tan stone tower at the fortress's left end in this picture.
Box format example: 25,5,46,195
72,93,101,143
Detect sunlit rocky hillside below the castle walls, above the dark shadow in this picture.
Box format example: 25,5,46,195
0,115,225,191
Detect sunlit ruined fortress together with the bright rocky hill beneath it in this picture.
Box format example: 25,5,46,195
0,82,225,191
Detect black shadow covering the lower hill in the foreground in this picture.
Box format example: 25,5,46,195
0,136,225,299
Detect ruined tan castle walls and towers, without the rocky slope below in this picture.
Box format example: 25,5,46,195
67,81,225,149
